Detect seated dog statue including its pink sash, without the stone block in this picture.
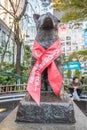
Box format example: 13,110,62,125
27,13,63,105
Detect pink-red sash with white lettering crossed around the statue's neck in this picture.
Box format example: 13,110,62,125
27,39,62,105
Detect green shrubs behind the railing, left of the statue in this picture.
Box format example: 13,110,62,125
0,63,29,85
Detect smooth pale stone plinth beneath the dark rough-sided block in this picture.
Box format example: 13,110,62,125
0,101,87,130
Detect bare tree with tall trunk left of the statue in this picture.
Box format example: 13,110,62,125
0,0,28,74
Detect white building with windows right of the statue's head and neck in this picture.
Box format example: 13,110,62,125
59,22,87,56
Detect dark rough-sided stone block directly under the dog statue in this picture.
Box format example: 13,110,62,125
16,92,75,123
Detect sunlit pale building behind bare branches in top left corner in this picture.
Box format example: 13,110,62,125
0,0,23,29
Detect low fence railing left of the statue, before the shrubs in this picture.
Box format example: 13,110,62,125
0,84,27,94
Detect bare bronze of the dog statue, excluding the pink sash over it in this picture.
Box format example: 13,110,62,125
32,13,64,98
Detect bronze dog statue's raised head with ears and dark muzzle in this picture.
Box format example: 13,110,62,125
33,13,60,30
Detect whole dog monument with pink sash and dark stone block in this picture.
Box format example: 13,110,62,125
16,13,75,124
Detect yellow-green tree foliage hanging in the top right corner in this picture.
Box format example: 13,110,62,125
53,0,87,22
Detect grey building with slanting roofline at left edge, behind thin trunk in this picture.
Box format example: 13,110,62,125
0,19,14,63
